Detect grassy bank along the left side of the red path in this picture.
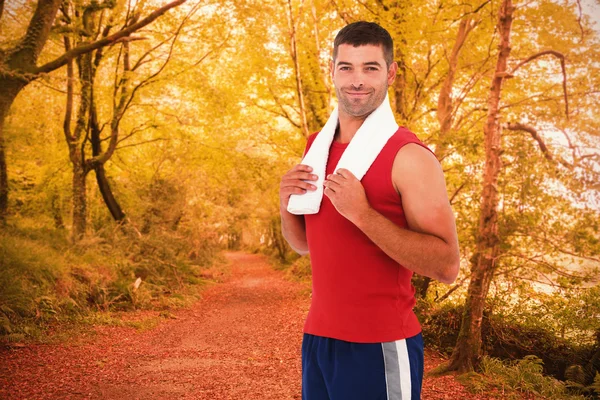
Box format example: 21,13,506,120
0,222,217,344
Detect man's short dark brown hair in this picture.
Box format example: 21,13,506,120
333,21,394,68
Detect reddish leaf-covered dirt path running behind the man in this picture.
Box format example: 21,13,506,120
0,253,476,400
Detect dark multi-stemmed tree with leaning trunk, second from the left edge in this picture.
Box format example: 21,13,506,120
61,3,137,241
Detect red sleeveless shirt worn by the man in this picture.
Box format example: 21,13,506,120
304,127,427,343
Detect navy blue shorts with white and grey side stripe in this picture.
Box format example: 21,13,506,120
302,333,423,400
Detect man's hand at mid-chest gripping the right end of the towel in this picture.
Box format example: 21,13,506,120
323,168,370,225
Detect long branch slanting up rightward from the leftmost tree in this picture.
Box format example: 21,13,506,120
35,0,186,73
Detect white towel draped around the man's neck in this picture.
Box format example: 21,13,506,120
287,95,398,215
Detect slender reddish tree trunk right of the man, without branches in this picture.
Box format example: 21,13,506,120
447,0,514,373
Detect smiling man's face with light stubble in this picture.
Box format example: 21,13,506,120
331,44,398,118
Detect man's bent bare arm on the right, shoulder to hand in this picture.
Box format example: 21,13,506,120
325,144,459,283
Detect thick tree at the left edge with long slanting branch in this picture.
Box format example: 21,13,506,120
0,0,186,223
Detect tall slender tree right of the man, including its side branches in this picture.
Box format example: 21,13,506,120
448,0,597,372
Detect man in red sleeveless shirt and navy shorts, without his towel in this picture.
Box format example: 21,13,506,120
280,22,459,400
